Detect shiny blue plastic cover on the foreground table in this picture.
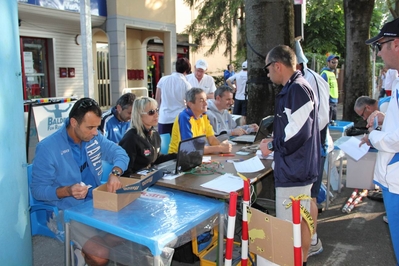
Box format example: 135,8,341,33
64,186,225,256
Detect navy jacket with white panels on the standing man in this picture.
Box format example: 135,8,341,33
273,71,320,187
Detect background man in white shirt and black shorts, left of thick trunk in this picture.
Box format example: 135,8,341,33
226,61,248,125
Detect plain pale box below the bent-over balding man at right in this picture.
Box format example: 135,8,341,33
346,149,377,189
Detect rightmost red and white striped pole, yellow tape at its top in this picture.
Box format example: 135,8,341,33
291,199,302,266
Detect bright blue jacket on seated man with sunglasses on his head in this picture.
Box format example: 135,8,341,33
30,118,129,209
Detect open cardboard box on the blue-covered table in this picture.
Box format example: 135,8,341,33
93,171,163,212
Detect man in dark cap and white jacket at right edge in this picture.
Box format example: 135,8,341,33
359,19,399,263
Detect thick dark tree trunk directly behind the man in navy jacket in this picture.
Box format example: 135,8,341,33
245,0,294,123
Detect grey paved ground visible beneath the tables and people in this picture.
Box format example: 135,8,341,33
33,105,396,266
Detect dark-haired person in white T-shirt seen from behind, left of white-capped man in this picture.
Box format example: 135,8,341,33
155,57,191,134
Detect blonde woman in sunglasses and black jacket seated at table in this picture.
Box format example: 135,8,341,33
119,97,176,176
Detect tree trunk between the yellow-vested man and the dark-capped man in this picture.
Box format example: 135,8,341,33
343,0,374,121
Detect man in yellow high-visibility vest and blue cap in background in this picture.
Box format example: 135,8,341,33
320,55,339,121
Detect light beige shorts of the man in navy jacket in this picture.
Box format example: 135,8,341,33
276,184,312,222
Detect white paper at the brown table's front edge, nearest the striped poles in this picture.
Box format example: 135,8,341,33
201,173,255,193
